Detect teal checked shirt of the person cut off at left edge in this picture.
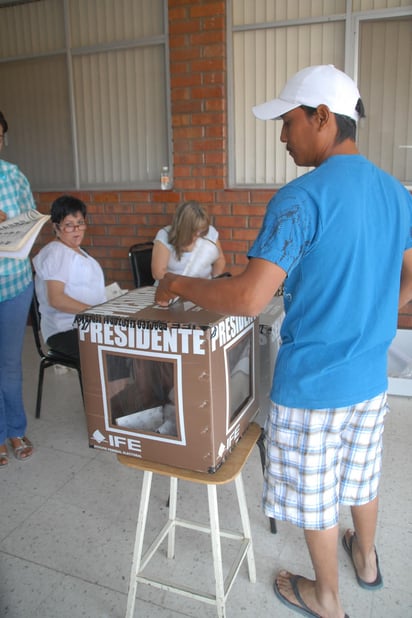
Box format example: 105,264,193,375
0,159,36,302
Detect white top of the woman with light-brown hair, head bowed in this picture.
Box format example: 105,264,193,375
155,225,219,279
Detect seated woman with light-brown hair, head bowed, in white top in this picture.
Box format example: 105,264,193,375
152,201,226,280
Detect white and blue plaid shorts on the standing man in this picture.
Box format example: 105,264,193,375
263,392,388,530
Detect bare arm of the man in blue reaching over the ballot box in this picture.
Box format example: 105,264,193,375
156,258,286,316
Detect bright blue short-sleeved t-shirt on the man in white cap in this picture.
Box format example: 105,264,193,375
249,155,412,409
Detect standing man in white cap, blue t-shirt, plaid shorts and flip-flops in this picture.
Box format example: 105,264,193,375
156,65,412,618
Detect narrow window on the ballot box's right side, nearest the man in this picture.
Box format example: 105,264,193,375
226,330,254,423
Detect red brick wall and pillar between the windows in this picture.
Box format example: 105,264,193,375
34,0,412,328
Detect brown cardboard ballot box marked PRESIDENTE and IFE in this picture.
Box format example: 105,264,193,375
76,287,258,472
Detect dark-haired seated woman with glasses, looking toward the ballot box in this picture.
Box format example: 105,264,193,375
33,195,106,358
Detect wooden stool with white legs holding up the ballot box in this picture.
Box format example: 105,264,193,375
117,423,261,618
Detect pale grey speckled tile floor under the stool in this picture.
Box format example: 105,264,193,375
0,331,412,618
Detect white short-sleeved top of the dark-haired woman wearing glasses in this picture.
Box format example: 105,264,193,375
33,240,106,341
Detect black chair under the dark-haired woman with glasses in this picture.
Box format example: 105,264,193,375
30,292,83,418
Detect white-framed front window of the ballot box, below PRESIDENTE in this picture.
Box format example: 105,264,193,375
105,353,178,437
